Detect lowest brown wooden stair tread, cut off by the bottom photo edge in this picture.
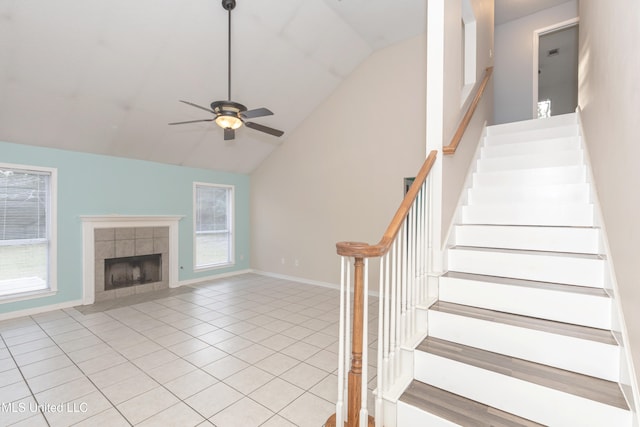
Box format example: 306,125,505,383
400,380,542,427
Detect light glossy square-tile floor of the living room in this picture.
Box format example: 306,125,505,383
0,274,373,427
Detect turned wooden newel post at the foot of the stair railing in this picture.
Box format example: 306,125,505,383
325,257,375,427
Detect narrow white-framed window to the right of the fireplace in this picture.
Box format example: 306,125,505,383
193,183,233,270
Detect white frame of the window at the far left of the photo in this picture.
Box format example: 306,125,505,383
0,163,58,304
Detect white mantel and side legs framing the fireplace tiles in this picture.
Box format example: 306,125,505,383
80,215,184,305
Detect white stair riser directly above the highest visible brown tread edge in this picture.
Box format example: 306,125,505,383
462,204,595,227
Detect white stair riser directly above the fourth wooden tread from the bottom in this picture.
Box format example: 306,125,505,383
448,248,604,288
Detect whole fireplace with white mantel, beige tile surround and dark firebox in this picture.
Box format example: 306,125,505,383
81,215,182,304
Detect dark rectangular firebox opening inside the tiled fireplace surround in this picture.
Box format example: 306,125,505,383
104,254,162,291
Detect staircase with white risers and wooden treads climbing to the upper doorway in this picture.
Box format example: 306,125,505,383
397,114,632,427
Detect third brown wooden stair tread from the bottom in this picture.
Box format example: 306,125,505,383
429,301,617,345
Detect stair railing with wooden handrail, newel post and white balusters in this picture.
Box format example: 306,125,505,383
326,150,437,427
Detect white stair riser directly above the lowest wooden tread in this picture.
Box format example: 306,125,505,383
415,352,631,427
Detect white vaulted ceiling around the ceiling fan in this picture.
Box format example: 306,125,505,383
0,0,561,173
